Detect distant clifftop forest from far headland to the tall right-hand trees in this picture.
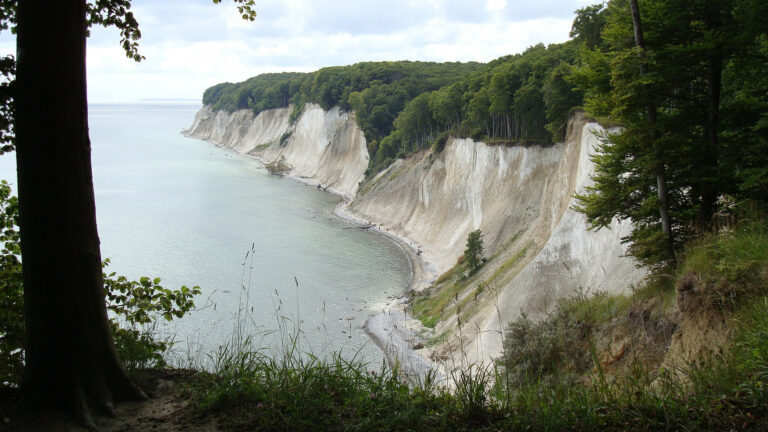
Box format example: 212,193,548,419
203,40,582,172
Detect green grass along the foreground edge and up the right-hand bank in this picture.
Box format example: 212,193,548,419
182,221,768,431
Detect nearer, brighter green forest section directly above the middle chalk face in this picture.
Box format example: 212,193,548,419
375,41,582,168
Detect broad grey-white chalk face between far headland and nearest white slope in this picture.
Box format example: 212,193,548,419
350,139,563,279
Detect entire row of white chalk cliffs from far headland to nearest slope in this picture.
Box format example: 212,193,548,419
186,105,644,361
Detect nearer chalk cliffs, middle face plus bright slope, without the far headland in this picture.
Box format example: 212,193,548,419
350,114,645,362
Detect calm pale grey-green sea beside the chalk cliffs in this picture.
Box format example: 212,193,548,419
0,104,410,362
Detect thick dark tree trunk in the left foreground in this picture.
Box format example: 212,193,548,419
16,0,144,422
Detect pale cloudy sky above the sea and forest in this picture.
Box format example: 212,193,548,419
0,0,597,103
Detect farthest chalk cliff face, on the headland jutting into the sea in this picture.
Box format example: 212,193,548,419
184,104,368,199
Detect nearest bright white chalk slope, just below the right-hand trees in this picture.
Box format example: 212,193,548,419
468,117,646,360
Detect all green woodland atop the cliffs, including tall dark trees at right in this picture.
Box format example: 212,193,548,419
203,0,768,266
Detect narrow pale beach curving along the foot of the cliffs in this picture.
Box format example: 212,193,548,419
181,130,440,383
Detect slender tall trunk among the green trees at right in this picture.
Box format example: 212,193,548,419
629,0,674,259
